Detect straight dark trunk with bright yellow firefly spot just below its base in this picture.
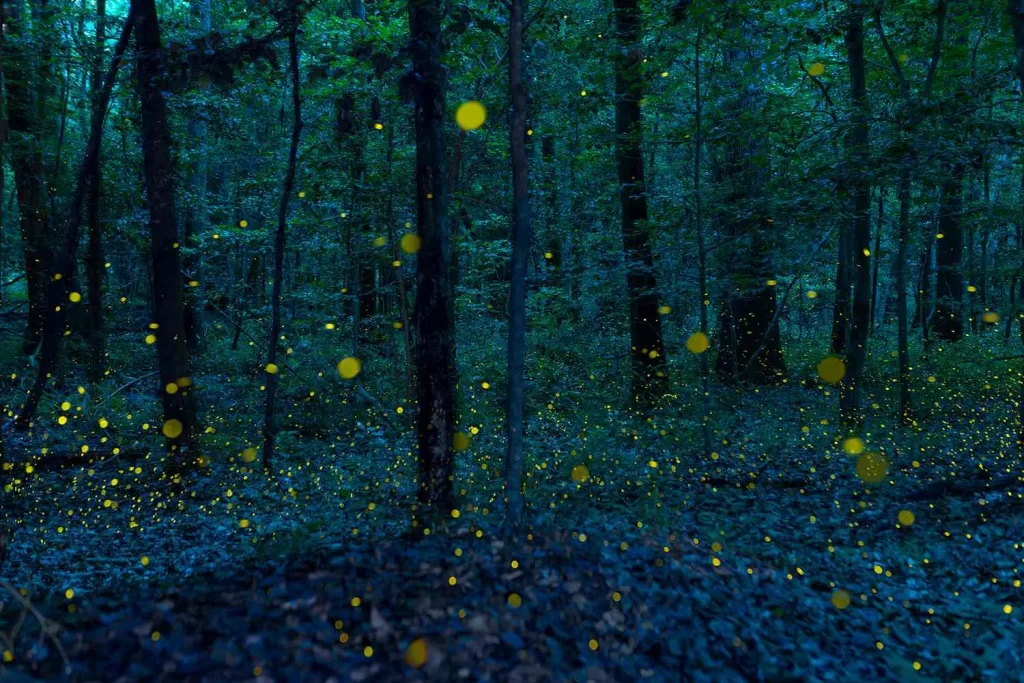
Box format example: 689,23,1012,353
840,0,878,423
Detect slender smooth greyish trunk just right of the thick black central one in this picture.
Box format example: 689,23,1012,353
505,0,531,536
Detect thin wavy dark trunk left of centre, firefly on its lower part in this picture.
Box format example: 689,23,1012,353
263,10,302,471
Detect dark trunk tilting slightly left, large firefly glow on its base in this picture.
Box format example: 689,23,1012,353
131,0,196,458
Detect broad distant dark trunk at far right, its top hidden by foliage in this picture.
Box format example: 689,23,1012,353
932,163,964,341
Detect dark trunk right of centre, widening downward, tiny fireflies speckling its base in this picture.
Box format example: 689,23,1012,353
615,0,669,411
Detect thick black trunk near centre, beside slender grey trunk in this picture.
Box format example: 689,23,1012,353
409,0,455,509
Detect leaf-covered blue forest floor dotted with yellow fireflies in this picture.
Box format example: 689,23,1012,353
0,311,1024,681
